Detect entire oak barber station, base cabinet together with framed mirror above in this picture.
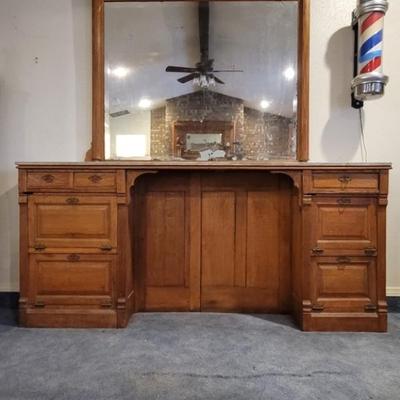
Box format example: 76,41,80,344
18,0,391,332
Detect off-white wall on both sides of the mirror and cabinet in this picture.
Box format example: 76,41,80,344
0,0,400,295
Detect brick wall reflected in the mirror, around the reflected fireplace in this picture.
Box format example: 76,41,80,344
151,91,296,159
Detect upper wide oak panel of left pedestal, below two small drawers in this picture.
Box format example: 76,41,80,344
29,196,117,252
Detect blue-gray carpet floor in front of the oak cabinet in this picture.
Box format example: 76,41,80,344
0,310,400,400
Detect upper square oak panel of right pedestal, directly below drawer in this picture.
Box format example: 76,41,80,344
311,197,376,255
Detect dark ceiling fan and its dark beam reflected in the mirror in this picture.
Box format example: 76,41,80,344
165,1,243,87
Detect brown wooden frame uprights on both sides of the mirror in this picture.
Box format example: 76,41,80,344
86,0,310,161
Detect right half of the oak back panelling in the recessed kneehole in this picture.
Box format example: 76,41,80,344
200,173,291,312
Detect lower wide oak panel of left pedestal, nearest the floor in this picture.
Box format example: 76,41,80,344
30,253,115,307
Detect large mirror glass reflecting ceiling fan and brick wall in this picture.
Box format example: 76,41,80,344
95,0,310,161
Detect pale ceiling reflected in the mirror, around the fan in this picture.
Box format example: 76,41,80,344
105,1,298,117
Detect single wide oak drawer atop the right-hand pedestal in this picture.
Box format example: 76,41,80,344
306,171,379,193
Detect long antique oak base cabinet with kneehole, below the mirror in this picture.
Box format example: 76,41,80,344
18,161,390,332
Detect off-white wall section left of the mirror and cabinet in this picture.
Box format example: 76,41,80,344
0,0,91,291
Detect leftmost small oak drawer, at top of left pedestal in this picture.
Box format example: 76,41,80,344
27,171,72,190
